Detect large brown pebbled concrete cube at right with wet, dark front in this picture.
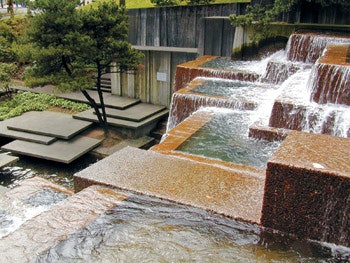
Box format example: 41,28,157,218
261,131,350,247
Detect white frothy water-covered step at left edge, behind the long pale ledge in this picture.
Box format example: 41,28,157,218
0,177,73,238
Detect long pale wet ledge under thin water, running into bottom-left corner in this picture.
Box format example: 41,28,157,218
0,186,127,262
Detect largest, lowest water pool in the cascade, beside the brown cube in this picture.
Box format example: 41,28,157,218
176,110,280,168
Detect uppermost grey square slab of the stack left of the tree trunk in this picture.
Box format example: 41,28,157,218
7,111,92,140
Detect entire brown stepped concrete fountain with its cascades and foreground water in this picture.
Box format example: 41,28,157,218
0,33,350,262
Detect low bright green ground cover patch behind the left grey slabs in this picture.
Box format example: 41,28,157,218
0,91,90,121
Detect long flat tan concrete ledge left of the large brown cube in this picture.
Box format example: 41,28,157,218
74,147,265,223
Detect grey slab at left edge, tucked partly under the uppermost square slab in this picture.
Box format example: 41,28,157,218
0,117,57,144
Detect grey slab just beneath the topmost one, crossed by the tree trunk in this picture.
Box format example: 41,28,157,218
73,109,169,138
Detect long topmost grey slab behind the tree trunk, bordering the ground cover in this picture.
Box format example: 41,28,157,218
11,85,140,110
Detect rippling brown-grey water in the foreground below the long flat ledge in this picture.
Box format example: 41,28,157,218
37,196,342,262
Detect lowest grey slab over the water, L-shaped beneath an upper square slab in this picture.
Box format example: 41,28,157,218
1,136,101,164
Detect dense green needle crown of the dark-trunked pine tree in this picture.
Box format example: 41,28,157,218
26,0,141,90
